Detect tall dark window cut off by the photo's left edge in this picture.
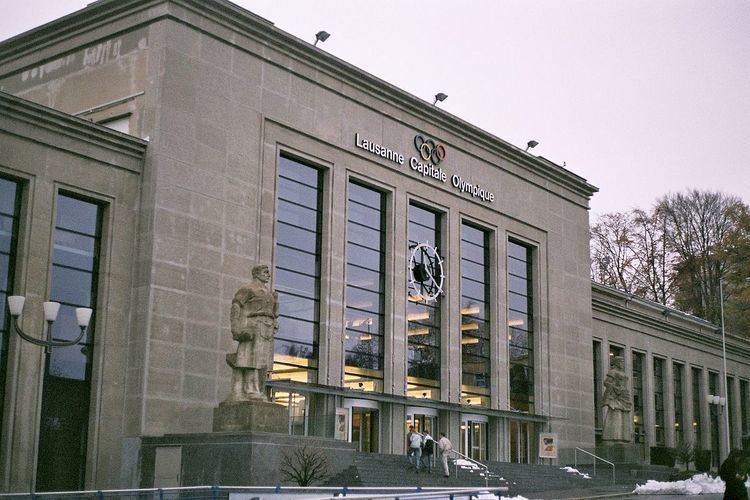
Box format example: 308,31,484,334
0,178,21,456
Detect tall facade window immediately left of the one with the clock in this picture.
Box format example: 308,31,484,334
344,182,385,392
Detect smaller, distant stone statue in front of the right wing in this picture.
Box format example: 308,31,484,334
602,356,633,443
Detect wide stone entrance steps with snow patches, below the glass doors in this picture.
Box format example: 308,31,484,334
325,453,652,496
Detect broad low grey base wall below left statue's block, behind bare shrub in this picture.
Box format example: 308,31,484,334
140,432,356,488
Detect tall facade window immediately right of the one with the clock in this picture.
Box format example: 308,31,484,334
461,223,490,406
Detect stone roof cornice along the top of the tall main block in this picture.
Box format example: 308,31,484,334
0,0,598,206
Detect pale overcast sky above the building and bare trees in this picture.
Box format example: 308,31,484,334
0,0,750,216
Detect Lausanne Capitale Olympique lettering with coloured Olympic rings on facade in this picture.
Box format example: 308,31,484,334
354,132,495,203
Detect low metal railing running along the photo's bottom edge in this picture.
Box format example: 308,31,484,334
0,486,507,500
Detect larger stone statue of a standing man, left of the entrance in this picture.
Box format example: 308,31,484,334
227,265,279,401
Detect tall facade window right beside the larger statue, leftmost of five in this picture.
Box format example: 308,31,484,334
273,156,323,382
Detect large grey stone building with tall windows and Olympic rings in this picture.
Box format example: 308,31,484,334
0,0,750,491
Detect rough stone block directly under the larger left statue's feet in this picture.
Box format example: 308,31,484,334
213,401,289,434
